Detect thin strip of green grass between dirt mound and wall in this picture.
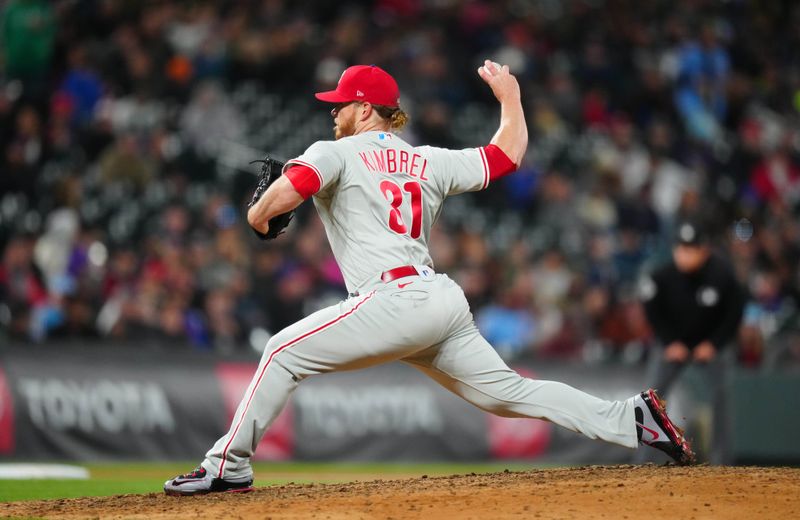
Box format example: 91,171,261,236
0,462,531,502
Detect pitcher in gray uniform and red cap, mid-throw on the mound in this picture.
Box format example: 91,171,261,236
164,60,694,495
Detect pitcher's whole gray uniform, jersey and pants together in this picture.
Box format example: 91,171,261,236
202,132,637,480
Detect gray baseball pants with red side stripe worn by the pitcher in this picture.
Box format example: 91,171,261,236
202,274,638,479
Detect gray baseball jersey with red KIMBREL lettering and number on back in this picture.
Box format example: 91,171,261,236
286,131,489,292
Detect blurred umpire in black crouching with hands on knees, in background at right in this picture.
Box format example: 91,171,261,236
640,218,745,464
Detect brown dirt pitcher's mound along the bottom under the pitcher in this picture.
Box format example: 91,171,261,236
0,465,800,520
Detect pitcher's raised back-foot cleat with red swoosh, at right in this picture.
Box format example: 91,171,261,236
635,388,696,466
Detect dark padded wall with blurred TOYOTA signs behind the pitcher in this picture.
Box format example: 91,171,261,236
0,346,800,464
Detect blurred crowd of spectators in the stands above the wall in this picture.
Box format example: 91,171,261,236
0,0,800,365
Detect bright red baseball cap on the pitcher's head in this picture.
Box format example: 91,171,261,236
315,65,400,108
